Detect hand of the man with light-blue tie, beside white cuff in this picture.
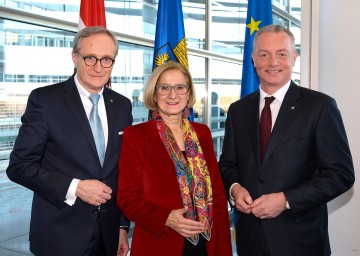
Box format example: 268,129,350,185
75,180,112,206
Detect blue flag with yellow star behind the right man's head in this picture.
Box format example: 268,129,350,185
240,0,272,98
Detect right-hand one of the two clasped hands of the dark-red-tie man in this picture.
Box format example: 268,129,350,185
251,192,286,219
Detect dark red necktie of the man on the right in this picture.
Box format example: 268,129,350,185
260,96,275,161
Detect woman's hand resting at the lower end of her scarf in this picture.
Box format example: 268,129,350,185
165,206,204,237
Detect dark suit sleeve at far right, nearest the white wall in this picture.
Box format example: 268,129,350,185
285,97,355,216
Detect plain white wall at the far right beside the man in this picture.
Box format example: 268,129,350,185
320,0,360,256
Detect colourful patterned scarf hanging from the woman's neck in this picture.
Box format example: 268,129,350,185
155,115,213,245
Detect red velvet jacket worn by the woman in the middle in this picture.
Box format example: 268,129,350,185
117,120,232,256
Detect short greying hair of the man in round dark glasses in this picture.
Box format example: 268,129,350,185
73,26,119,56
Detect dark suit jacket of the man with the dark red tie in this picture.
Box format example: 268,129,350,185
219,82,355,256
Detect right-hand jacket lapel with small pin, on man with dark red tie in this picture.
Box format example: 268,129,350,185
263,82,301,164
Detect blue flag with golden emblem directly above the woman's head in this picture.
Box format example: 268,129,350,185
153,0,189,69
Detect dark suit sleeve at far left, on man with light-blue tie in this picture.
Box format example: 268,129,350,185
6,90,72,205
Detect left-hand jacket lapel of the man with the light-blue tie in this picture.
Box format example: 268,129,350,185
64,77,100,160
